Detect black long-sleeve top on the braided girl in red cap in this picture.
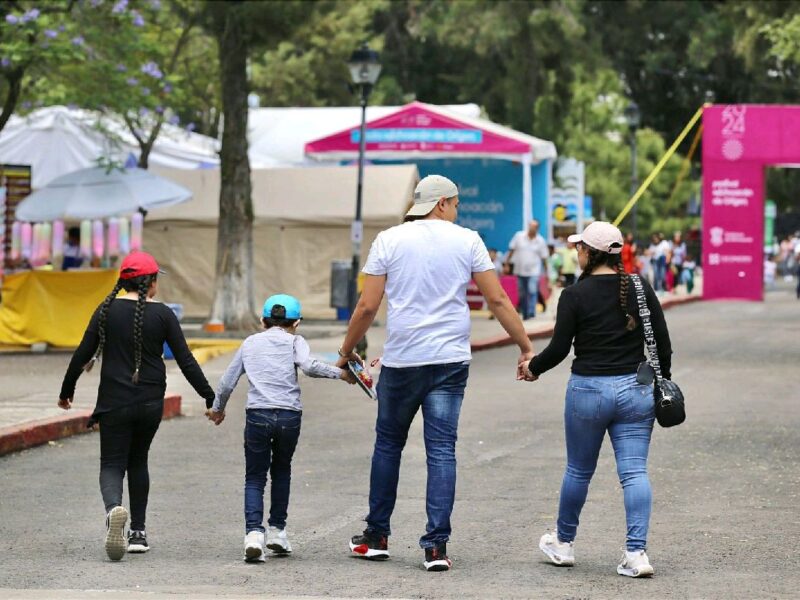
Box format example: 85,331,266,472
59,299,214,420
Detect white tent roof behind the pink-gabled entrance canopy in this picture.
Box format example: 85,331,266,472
247,104,481,165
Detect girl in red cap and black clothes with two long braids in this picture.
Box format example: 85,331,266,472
58,252,214,560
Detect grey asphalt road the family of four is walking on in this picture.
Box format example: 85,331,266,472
0,289,800,600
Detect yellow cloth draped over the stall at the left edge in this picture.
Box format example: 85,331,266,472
0,270,118,348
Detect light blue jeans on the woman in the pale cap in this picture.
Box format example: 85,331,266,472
558,374,655,552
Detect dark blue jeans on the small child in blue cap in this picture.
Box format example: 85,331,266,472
244,408,303,533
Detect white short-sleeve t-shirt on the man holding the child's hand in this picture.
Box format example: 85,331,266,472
363,219,494,368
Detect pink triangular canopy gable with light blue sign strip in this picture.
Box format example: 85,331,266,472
305,102,531,156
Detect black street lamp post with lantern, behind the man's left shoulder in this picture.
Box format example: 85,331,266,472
347,44,381,354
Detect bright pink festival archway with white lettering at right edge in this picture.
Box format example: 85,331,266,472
703,104,800,300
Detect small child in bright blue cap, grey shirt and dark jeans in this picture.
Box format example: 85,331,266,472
207,294,355,562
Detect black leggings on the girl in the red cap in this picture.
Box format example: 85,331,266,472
100,400,164,531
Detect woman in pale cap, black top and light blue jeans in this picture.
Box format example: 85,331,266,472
526,221,672,577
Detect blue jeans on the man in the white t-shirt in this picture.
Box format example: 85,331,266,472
367,363,469,548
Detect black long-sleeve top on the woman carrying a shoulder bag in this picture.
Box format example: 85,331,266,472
529,274,672,379
